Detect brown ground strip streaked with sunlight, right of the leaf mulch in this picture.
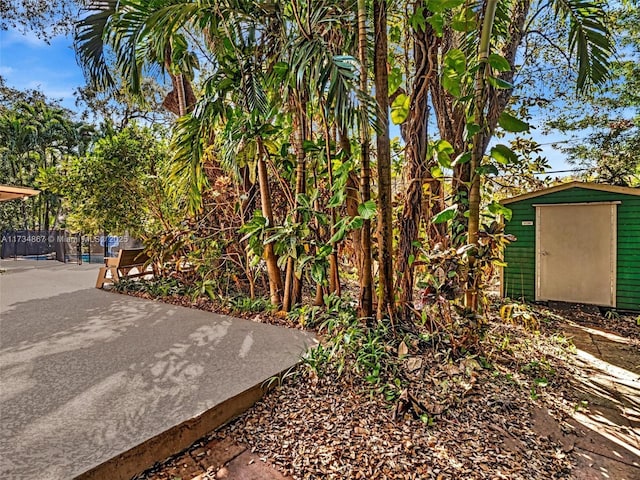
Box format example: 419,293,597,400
538,319,640,480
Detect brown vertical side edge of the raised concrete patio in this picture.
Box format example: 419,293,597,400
74,382,269,480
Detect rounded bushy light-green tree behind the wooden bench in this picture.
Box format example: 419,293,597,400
38,124,171,236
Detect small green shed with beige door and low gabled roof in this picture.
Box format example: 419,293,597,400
502,182,640,311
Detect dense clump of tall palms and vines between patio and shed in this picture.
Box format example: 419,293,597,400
66,0,613,334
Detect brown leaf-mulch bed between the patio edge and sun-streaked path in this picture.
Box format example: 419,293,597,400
126,290,640,480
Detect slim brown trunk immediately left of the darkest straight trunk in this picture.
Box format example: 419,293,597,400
358,0,372,319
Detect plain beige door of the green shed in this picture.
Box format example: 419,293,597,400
536,202,617,307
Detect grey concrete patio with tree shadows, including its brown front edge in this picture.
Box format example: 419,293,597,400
0,261,314,480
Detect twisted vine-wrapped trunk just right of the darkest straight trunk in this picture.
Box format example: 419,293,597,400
398,19,440,319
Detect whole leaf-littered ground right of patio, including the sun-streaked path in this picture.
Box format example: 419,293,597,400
136,304,640,480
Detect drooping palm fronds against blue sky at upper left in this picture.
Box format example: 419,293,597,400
75,0,198,116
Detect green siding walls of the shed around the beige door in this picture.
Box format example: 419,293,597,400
503,187,640,310
